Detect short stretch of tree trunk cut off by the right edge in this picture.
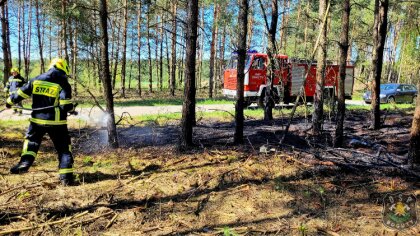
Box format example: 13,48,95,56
408,94,420,164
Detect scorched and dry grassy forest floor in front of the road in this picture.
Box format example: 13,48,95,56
0,111,420,235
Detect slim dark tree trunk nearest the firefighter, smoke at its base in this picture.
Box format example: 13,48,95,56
99,0,118,148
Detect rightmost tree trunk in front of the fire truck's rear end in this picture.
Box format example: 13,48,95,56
334,0,350,147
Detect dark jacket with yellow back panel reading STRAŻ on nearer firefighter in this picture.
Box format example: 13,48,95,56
7,67,75,125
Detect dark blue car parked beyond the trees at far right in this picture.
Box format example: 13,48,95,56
363,84,417,104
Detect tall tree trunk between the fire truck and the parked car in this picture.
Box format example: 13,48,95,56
371,0,388,130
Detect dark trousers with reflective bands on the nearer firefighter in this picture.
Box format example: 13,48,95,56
21,122,73,174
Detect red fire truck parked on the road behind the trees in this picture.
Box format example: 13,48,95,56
223,51,354,106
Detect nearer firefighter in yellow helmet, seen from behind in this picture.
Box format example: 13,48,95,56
6,58,77,186
